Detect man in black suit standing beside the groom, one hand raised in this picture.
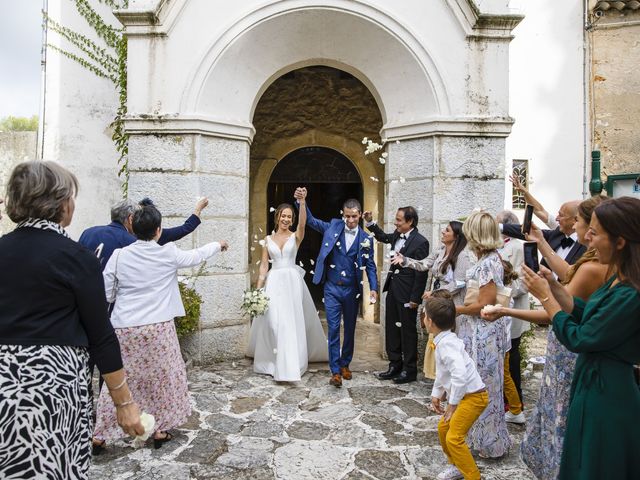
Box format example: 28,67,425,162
363,207,429,383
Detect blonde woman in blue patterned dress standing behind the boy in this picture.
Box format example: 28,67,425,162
456,212,511,458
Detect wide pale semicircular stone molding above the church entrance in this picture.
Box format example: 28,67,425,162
180,0,450,133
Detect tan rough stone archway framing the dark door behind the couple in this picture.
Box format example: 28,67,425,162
249,66,384,320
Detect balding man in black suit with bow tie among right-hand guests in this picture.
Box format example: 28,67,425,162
501,200,587,268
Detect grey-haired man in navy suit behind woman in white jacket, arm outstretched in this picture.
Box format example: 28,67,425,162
78,197,209,270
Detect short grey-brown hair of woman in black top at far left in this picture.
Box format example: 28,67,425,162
5,160,78,223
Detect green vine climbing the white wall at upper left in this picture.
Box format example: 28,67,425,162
43,0,129,198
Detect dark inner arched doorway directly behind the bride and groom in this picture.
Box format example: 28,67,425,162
267,147,363,310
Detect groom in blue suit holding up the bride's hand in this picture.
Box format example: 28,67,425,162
294,188,378,388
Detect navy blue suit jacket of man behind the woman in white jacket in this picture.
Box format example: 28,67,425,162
78,215,200,270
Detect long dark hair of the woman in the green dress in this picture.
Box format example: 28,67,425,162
593,197,640,292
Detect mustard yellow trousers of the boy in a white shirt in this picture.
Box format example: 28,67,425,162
438,391,489,480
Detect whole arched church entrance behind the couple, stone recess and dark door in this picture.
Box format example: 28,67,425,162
248,66,385,321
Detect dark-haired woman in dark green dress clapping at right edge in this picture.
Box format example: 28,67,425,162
523,197,640,480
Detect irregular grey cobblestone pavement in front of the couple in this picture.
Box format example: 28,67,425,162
90,322,539,480
